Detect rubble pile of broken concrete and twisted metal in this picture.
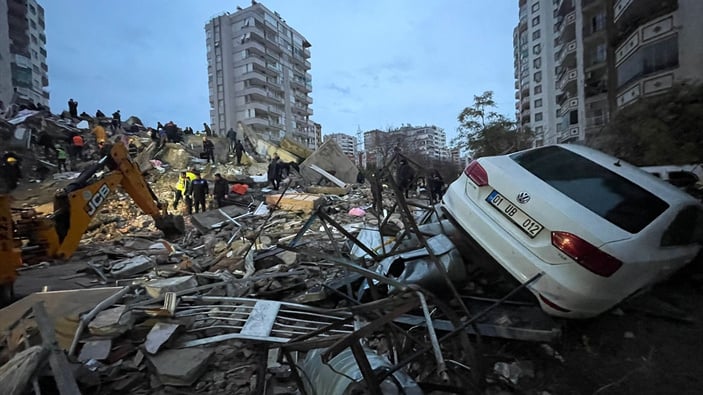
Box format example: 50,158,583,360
0,110,696,394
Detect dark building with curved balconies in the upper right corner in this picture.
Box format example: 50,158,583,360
613,0,703,108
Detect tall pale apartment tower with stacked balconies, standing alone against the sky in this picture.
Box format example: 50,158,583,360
205,1,320,149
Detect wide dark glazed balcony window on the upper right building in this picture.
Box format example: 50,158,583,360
618,35,679,88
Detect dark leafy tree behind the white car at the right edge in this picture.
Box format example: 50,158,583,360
587,83,703,166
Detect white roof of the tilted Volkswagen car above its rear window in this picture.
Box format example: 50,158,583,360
516,144,701,205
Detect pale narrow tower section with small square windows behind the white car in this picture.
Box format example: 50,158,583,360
513,0,557,145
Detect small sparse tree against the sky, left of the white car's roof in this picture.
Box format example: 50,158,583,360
452,91,533,158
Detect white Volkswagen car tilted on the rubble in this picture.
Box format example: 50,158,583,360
442,144,703,318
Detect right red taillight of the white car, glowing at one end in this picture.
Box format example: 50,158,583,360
552,232,622,277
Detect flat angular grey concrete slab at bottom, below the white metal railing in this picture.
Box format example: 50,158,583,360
149,348,214,386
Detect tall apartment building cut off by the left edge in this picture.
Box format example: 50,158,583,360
0,0,49,106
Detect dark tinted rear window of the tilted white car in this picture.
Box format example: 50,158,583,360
510,146,669,233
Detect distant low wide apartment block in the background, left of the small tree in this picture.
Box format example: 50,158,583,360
364,125,449,166
